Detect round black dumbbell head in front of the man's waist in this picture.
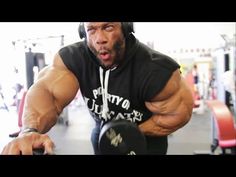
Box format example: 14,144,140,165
98,120,147,155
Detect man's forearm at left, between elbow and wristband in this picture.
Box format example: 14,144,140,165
22,86,62,133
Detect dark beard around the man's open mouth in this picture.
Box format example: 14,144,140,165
87,39,125,69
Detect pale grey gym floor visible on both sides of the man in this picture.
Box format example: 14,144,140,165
0,100,220,155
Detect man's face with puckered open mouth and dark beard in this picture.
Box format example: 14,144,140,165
84,22,125,68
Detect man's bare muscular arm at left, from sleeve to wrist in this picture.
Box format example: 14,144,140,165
23,56,79,133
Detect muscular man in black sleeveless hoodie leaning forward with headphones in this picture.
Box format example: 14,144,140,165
2,22,193,154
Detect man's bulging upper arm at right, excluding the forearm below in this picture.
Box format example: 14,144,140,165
145,70,193,128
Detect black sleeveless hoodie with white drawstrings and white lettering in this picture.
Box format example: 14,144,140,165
59,34,179,154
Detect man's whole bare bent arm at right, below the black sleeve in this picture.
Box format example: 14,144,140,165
139,70,193,136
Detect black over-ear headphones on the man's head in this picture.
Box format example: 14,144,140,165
78,22,134,39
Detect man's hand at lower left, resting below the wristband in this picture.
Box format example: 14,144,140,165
1,132,54,155
